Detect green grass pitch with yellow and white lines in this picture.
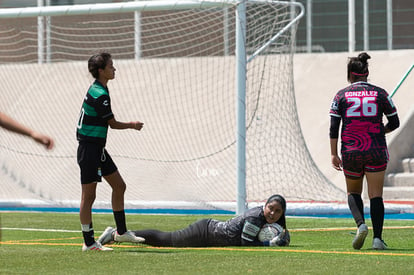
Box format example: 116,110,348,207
0,213,414,274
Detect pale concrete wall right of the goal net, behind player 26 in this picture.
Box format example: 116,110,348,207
294,50,414,190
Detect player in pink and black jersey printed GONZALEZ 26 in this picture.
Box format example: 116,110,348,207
329,53,400,252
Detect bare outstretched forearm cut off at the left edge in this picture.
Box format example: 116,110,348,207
0,112,54,149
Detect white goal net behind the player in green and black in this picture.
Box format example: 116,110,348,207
0,1,344,213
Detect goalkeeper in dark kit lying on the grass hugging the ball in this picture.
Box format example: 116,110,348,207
99,195,290,247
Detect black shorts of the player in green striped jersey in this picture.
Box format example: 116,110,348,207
78,142,118,184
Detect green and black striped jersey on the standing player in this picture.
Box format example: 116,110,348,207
76,80,114,146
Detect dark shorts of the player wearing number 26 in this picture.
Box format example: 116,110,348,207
342,148,389,178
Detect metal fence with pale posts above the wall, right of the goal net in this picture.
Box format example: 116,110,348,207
297,0,414,52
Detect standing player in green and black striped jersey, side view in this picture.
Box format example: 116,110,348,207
76,52,144,251
